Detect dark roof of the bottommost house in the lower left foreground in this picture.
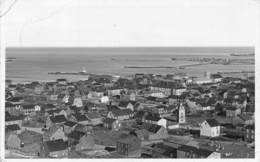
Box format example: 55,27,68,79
44,139,68,152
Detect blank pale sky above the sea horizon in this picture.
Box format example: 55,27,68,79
2,0,260,47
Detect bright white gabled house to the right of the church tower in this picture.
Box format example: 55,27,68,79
200,119,220,137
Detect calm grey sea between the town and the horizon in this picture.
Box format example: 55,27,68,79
6,47,255,83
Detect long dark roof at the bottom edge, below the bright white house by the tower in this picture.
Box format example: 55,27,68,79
178,145,213,157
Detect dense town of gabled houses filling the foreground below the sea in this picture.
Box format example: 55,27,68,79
5,73,255,159
